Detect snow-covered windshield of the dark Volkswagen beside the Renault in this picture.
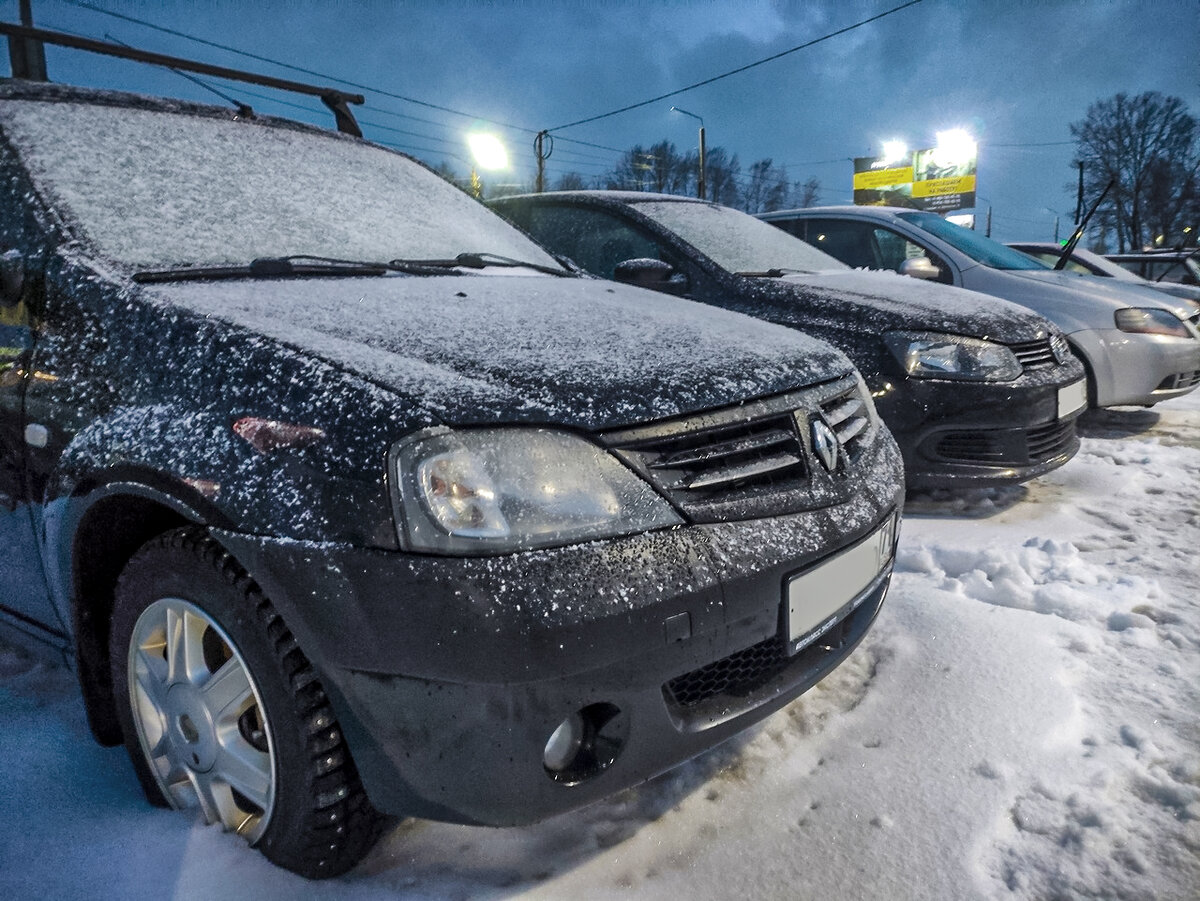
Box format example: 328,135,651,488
636,200,848,272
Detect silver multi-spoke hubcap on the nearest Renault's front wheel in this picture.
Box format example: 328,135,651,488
127,597,276,843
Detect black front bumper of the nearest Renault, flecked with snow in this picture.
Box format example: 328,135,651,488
214,442,902,825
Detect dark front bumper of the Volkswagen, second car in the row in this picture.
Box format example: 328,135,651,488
872,361,1086,488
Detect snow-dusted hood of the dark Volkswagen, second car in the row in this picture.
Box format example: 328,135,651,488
776,269,1050,342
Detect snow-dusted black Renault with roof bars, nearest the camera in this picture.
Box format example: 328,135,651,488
0,82,902,876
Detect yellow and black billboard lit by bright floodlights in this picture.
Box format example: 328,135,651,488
854,148,978,214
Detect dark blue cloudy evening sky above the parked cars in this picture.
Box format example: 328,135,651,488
9,0,1200,240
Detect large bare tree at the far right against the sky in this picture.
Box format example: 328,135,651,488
1070,91,1200,251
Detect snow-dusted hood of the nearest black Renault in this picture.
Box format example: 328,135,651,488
145,275,851,430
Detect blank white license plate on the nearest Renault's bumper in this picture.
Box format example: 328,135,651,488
786,513,896,654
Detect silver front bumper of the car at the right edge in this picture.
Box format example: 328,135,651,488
1067,329,1200,407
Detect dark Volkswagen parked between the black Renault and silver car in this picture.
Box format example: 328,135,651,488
492,191,1086,496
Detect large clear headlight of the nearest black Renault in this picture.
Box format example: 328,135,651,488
391,428,683,554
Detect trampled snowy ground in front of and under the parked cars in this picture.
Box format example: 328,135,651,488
0,392,1200,901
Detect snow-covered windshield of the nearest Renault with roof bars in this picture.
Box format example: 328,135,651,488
0,101,562,269
